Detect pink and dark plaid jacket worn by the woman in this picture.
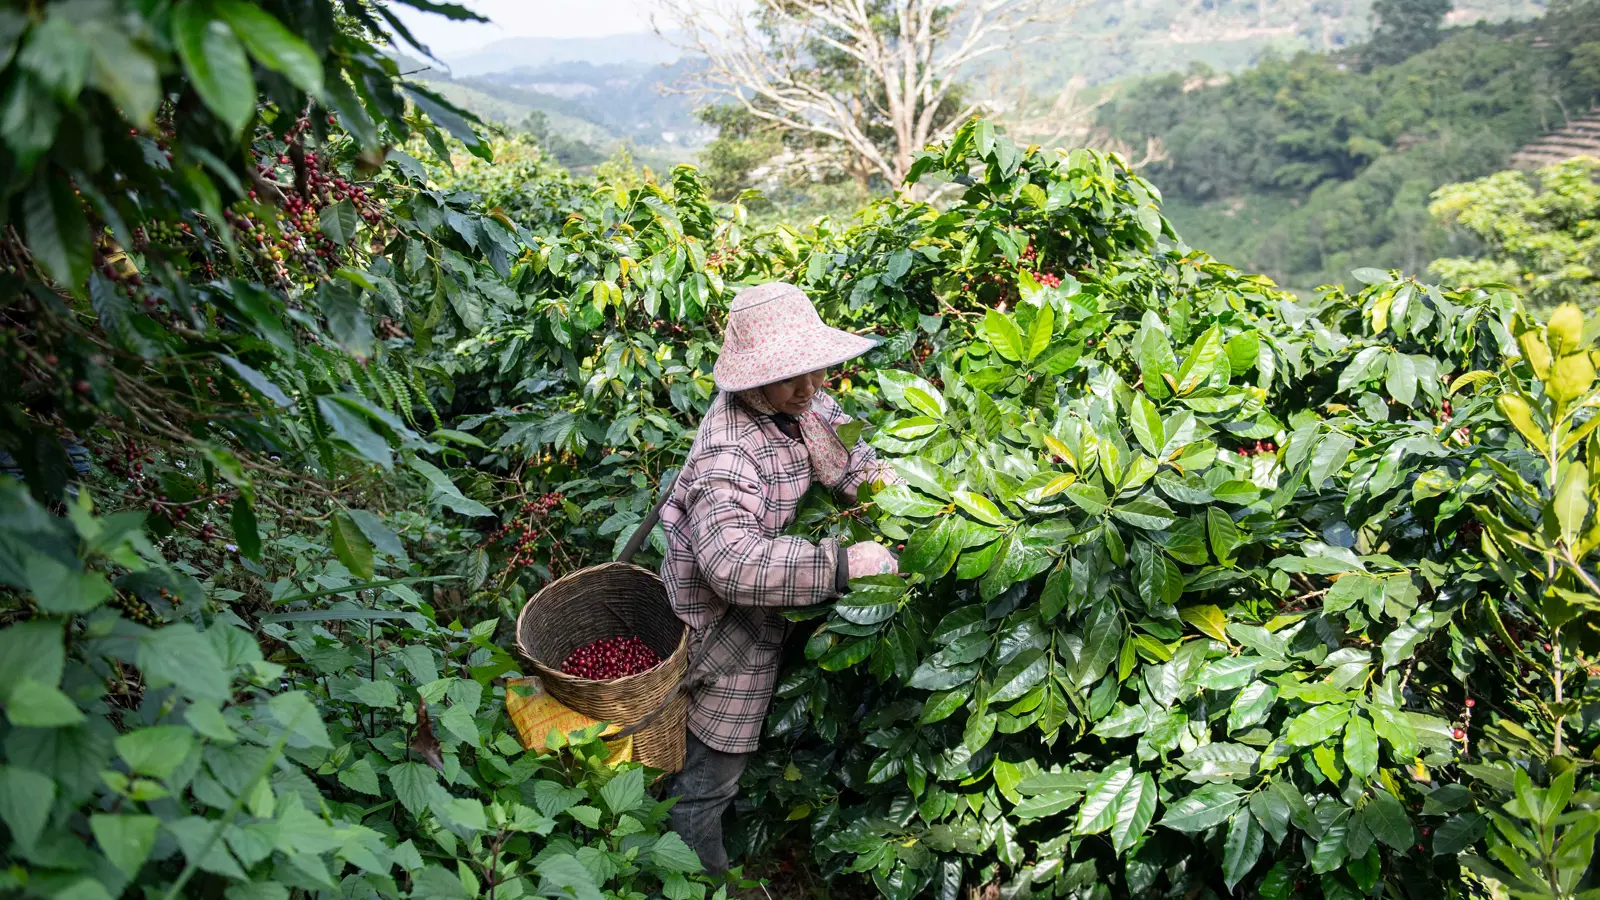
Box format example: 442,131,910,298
661,392,894,753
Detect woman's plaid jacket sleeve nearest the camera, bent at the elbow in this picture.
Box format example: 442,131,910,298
685,447,843,607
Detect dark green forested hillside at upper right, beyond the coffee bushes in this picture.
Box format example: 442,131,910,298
1101,0,1600,288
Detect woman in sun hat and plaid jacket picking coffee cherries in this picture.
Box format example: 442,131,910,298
661,283,898,871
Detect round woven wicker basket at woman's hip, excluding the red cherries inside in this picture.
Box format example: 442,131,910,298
517,562,690,772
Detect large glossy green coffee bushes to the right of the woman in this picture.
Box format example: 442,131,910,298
732,127,1600,897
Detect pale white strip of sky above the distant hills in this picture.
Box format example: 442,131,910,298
392,0,656,56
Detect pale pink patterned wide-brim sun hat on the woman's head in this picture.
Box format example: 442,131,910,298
712,282,878,392
